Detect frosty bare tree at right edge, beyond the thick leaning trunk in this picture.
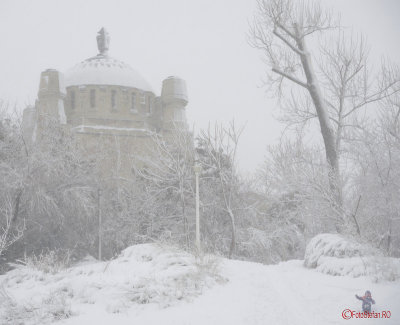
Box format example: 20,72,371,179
352,89,400,256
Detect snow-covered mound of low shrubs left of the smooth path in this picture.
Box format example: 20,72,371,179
0,244,224,325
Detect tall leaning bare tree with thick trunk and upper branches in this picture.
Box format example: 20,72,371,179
251,0,338,171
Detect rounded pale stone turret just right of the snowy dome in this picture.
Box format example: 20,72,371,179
161,77,188,130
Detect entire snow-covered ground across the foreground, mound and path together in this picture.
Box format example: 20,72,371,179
0,245,400,325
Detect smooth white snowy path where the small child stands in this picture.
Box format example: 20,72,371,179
58,260,400,325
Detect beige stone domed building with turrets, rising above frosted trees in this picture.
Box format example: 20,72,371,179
23,28,188,177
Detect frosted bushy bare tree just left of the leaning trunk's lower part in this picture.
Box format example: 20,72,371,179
260,136,343,232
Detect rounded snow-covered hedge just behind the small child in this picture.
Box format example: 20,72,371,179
304,234,400,281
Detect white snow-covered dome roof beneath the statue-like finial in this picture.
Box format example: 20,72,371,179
65,54,154,93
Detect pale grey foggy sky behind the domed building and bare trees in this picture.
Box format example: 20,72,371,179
0,0,400,172
